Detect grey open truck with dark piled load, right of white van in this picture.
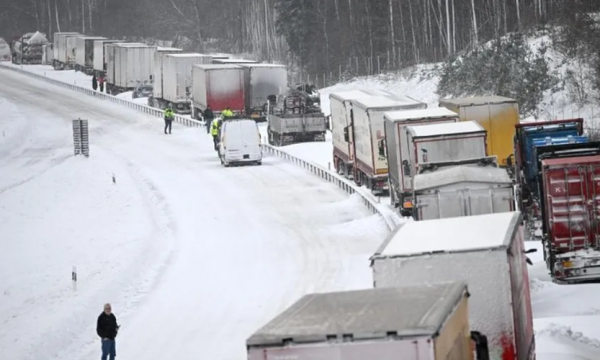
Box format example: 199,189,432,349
267,90,327,146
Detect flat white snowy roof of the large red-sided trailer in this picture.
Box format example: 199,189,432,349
372,211,521,259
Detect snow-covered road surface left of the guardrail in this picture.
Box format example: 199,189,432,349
0,69,387,360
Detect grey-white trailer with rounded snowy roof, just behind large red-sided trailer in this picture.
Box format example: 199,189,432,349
414,164,515,220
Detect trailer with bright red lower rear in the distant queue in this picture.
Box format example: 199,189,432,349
192,64,246,114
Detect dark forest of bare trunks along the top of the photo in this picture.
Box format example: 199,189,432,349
0,0,600,82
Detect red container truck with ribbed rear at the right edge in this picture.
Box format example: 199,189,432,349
538,142,600,284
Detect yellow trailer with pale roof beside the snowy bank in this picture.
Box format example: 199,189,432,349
439,96,519,167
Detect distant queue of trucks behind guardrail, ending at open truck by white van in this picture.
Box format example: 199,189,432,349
41,32,327,132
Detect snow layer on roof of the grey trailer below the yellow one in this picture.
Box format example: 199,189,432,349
413,166,512,191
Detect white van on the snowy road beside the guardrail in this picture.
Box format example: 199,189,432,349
219,119,262,166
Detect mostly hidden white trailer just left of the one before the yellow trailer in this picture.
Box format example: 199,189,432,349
379,108,459,216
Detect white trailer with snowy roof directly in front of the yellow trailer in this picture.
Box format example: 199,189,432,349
403,121,487,190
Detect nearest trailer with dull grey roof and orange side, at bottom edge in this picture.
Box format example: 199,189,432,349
246,282,473,360
